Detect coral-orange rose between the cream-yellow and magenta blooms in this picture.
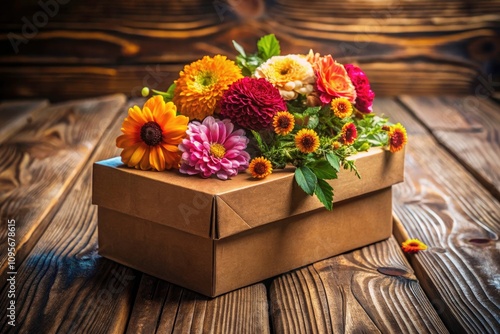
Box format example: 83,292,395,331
316,55,356,104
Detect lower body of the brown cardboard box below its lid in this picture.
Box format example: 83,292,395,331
99,187,392,297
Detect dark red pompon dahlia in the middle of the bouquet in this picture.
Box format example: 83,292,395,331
220,77,287,130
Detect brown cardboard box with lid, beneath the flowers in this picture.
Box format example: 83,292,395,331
93,149,404,297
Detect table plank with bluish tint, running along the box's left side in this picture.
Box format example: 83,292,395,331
0,96,137,333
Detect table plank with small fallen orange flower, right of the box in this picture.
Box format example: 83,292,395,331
377,99,500,333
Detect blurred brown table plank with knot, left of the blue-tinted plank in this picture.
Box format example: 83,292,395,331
0,95,125,280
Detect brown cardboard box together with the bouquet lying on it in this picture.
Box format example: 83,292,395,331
92,35,407,297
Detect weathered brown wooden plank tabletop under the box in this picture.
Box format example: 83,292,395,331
0,95,500,333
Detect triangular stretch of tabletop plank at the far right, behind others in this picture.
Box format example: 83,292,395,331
401,95,500,200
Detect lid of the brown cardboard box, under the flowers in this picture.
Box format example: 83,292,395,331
93,148,404,239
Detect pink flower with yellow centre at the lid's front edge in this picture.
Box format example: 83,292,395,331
179,116,250,180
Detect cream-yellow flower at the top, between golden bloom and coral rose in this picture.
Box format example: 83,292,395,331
255,55,315,100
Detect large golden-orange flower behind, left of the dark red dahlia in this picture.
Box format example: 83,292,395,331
173,55,243,121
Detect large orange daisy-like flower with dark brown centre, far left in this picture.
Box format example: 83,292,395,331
116,95,189,171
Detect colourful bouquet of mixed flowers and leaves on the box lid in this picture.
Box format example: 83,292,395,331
116,34,407,210
